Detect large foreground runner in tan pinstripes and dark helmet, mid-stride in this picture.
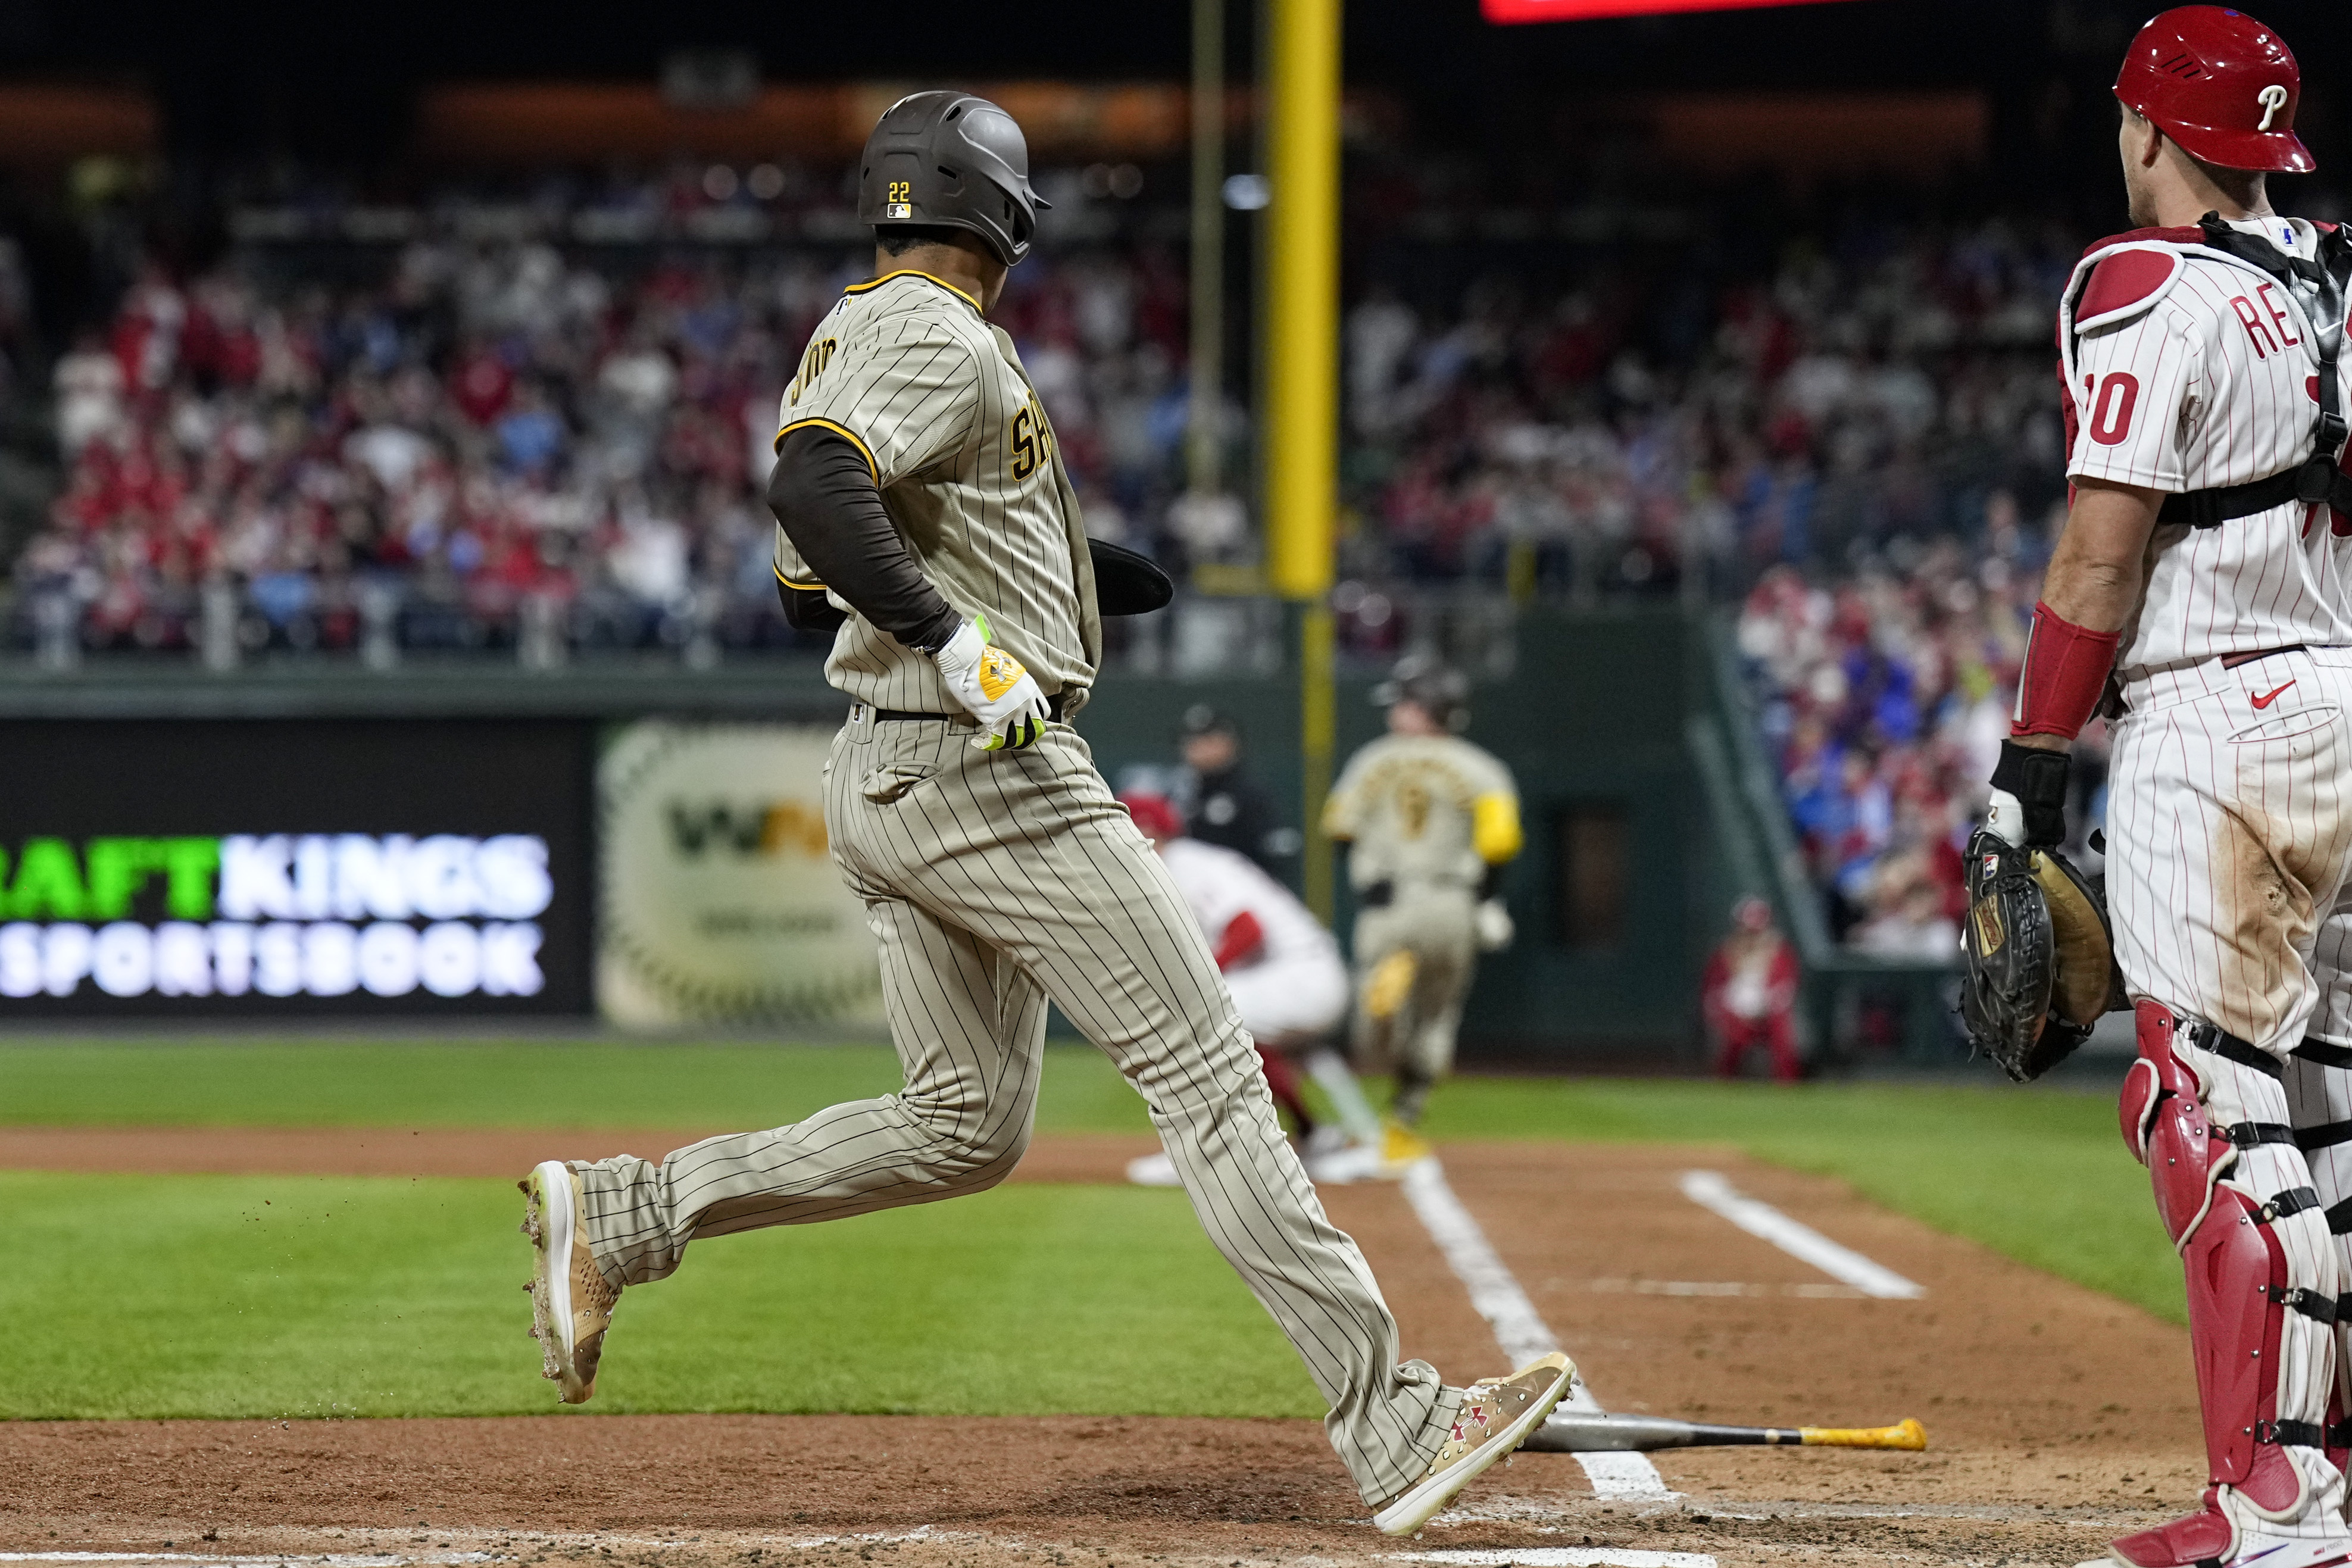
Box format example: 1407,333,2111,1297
524,92,1571,1533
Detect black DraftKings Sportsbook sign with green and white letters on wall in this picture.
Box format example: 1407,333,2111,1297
0,719,593,1018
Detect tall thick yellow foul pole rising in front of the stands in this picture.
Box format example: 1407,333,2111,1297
1258,0,1341,919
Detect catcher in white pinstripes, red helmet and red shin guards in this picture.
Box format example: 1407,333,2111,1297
1971,15,2352,1568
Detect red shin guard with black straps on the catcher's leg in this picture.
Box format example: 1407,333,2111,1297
2122,1001,2342,1519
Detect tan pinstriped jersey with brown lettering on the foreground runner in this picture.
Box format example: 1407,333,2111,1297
776,270,1103,715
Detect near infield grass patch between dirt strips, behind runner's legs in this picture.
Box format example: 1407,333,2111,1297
0,1173,1322,1417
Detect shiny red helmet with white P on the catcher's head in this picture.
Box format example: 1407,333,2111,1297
2114,5,2319,174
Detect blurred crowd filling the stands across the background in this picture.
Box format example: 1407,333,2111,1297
10,176,2072,957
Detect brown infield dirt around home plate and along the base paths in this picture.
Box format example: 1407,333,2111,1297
0,1129,2204,1568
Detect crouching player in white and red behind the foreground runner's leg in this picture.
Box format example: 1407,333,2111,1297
1120,790,1402,1187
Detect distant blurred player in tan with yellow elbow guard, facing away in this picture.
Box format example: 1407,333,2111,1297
1322,658,1519,1159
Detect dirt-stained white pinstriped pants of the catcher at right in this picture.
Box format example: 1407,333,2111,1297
2107,649,2352,1530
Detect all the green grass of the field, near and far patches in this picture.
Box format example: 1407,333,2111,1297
0,1041,2183,1415
